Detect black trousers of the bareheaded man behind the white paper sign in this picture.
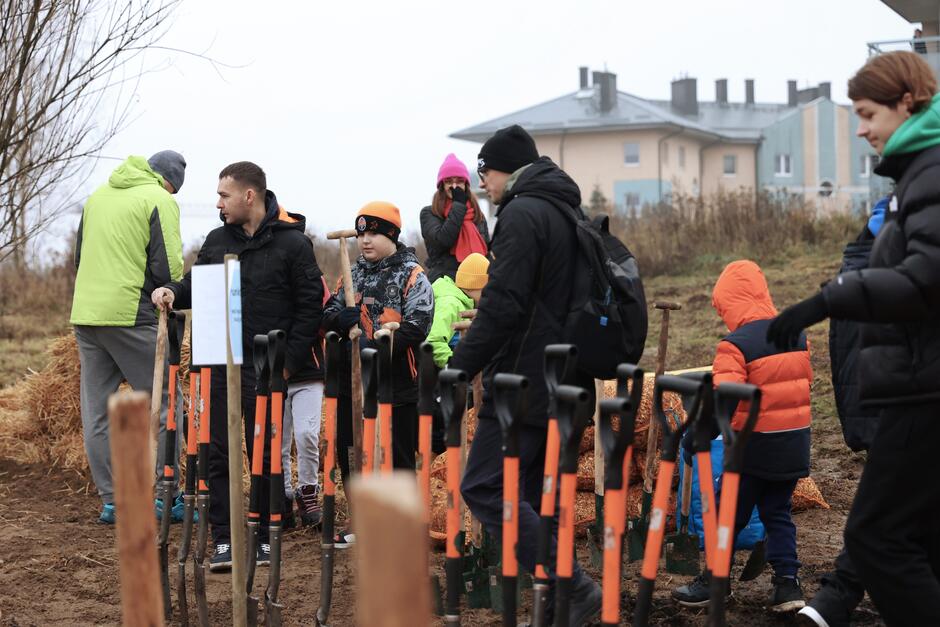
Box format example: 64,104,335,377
209,367,276,544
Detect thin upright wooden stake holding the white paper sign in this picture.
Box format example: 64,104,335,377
225,255,246,627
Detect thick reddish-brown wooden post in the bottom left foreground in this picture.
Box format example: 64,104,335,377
108,392,163,627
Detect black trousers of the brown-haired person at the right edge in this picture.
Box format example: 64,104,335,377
845,403,940,625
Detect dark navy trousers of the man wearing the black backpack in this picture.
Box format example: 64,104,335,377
460,418,583,585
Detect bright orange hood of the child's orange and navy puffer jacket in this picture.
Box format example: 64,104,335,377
712,260,777,331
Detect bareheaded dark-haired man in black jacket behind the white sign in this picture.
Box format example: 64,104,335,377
151,161,323,571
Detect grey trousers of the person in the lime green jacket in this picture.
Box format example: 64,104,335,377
75,325,183,503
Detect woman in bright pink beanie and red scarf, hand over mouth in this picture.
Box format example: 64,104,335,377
421,153,490,283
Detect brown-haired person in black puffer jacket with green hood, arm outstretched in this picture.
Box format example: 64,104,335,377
767,51,940,625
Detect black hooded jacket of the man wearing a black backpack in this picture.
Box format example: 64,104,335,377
451,157,594,426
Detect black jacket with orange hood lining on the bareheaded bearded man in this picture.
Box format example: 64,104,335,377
166,190,323,382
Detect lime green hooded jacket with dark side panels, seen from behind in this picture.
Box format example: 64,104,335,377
69,156,183,327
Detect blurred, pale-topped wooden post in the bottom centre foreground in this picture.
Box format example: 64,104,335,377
350,471,431,627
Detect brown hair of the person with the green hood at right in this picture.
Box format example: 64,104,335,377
849,50,937,113
